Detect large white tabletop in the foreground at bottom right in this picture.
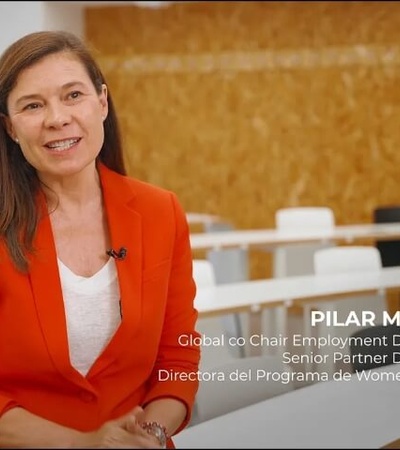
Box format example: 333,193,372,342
174,364,400,449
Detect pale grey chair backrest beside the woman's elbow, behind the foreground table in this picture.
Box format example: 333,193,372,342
195,355,294,423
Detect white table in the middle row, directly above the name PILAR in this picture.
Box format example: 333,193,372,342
195,267,400,354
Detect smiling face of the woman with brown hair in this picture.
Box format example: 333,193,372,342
6,52,108,183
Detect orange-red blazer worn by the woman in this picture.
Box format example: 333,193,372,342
0,165,199,442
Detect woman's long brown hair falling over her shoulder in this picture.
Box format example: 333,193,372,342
0,31,126,272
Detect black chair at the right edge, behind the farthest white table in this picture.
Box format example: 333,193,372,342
374,205,400,267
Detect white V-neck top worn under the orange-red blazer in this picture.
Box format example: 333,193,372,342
58,258,121,376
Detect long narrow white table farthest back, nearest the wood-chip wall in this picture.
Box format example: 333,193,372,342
190,223,400,250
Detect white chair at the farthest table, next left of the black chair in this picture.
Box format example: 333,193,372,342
273,206,335,277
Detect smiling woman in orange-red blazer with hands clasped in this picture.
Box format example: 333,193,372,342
0,32,199,448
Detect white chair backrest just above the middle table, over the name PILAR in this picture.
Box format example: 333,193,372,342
314,245,382,275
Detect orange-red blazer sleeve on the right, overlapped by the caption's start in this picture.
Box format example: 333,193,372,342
144,193,200,433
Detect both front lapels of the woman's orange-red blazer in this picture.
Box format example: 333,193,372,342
29,165,142,387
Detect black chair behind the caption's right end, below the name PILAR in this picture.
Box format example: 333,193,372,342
349,325,400,372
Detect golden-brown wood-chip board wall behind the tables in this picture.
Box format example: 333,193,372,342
86,1,400,275
